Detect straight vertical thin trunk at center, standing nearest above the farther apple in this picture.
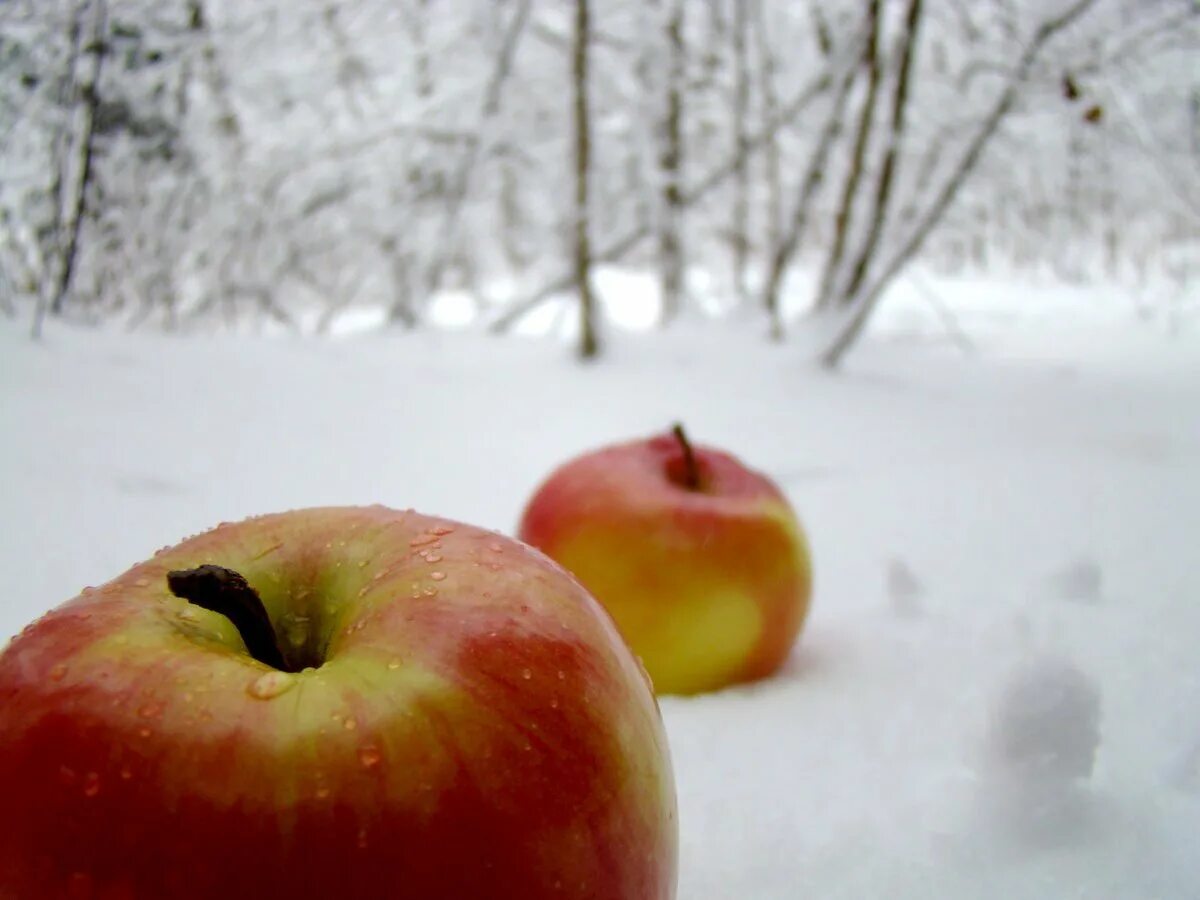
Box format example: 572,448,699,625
571,0,600,359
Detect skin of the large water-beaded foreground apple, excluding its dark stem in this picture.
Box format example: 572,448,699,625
0,508,677,900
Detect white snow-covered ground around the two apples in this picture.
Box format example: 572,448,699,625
0,282,1200,900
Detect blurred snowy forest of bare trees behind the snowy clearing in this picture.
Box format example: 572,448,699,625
0,0,1200,365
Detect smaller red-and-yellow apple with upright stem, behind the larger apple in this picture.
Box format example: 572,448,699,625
518,426,812,694
